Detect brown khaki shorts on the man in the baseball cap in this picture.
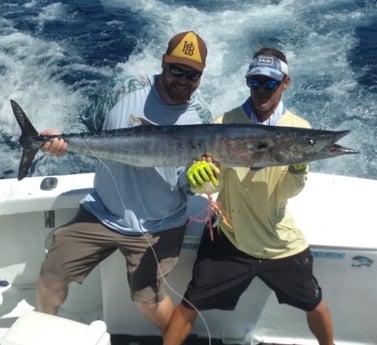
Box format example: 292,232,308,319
41,206,185,303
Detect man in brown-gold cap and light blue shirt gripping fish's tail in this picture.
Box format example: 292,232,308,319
37,31,217,336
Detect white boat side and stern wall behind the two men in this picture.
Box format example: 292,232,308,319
0,173,377,345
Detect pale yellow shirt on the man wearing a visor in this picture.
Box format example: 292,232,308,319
216,107,310,259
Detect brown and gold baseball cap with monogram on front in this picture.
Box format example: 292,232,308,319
162,31,207,72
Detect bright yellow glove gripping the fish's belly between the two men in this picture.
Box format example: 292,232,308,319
186,160,220,193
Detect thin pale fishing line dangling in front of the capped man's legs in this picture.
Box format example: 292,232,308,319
90,154,212,345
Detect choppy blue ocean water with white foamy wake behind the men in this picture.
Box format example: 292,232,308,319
0,0,377,179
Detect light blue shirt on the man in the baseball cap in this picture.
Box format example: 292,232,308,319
82,76,212,235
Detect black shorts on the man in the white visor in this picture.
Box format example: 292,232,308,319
182,229,322,311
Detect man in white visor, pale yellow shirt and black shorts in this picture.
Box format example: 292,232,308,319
164,48,334,345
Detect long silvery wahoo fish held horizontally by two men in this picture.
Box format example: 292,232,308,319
11,100,357,180
